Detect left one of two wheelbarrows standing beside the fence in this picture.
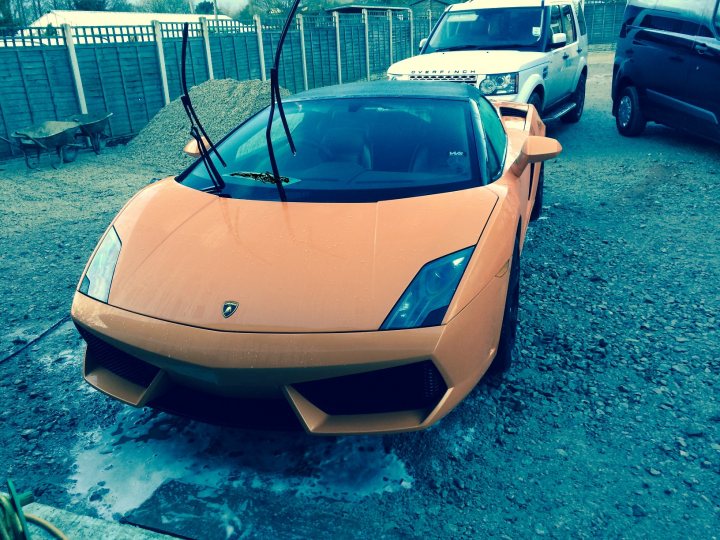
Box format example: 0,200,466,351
2,120,80,169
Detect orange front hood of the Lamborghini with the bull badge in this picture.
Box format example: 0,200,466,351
108,179,497,332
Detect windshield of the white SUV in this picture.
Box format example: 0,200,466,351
423,7,543,53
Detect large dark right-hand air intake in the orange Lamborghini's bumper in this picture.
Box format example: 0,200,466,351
293,360,447,415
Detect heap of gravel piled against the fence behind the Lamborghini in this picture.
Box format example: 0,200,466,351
126,79,290,174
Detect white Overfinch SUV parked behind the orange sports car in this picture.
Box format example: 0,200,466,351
388,0,588,122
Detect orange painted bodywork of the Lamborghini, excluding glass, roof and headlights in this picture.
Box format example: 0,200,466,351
72,103,561,434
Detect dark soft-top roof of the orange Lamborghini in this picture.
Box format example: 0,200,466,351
283,81,482,101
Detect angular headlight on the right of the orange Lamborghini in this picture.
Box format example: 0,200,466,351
380,246,475,330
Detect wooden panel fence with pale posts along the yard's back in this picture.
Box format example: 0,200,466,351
0,5,624,157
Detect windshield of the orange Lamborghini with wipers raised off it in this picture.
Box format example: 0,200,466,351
178,97,481,202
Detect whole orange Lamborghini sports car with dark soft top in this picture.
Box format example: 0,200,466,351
72,81,561,434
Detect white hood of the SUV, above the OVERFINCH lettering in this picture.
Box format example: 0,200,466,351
388,51,547,75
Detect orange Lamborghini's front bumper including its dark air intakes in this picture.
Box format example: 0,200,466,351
72,279,506,434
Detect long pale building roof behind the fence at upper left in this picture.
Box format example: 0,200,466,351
30,9,231,28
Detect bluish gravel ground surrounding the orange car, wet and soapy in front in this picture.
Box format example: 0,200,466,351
0,55,720,538
